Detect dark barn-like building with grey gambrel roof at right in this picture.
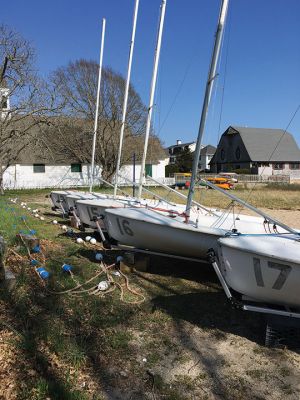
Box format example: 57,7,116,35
210,126,300,176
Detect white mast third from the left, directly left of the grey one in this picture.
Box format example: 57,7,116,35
137,0,167,200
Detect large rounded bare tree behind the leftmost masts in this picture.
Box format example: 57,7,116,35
51,60,161,180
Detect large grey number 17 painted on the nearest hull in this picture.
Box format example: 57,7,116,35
253,257,292,290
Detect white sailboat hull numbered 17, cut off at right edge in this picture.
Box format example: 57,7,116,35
219,235,300,307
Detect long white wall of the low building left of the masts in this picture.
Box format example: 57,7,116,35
3,164,100,189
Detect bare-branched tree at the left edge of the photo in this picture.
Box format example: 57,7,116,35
0,25,51,193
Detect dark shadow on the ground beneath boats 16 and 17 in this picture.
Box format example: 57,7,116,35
137,257,265,345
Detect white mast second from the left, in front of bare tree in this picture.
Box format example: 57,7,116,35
114,0,139,198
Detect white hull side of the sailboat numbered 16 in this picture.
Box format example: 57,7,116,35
105,208,226,258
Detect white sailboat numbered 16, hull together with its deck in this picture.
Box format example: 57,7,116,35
105,208,294,258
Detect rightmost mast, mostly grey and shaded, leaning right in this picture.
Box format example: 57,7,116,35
185,0,229,222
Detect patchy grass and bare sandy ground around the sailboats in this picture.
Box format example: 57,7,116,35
0,188,300,400
